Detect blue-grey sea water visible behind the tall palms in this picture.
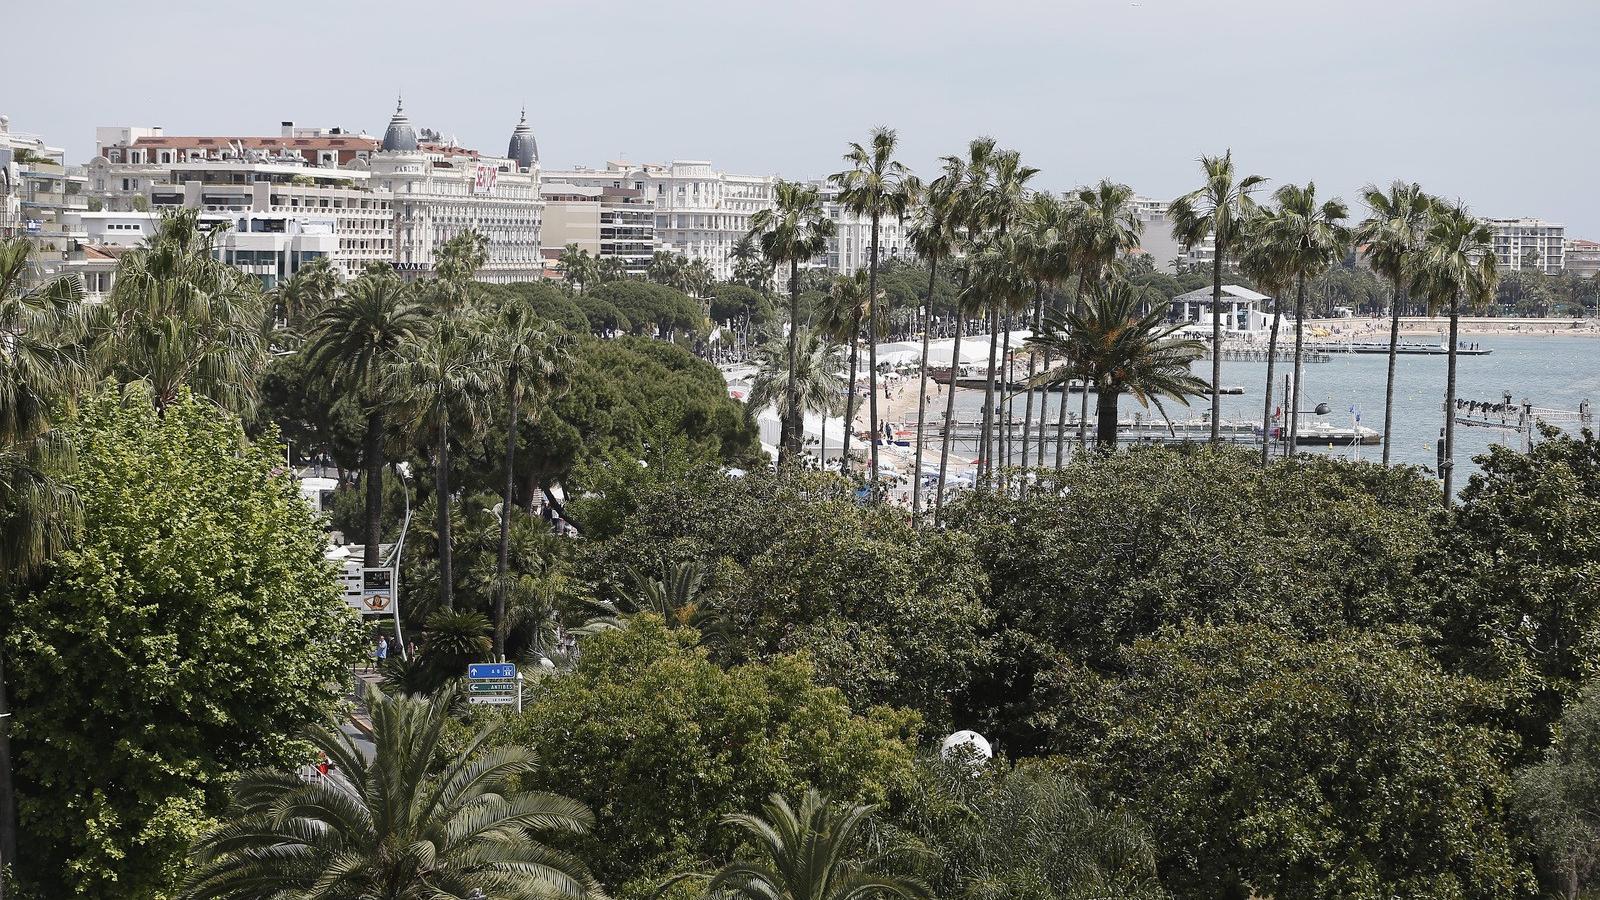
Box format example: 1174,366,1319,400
957,335,1600,485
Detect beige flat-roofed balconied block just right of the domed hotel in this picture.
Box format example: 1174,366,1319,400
539,178,656,275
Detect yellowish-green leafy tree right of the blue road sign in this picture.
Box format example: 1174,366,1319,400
496,613,915,897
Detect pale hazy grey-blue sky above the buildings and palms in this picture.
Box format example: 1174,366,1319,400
12,0,1600,239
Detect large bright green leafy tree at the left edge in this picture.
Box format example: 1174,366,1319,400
5,392,362,897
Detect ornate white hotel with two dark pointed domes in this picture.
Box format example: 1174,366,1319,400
371,104,544,283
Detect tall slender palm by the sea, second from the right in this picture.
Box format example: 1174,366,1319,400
1355,181,1434,466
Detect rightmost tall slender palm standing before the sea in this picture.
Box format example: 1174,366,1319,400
1410,200,1499,506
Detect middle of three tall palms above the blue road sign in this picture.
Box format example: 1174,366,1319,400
389,320,499,610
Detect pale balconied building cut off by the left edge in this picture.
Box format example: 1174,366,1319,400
0,115,90,279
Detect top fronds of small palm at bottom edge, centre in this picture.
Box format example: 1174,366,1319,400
674,788,928,900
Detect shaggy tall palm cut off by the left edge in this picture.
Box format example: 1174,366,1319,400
0,237,88,860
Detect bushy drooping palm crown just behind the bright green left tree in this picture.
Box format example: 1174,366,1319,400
93,210,267,413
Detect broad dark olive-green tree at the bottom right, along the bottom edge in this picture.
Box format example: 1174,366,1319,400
1062,626,1531,900
